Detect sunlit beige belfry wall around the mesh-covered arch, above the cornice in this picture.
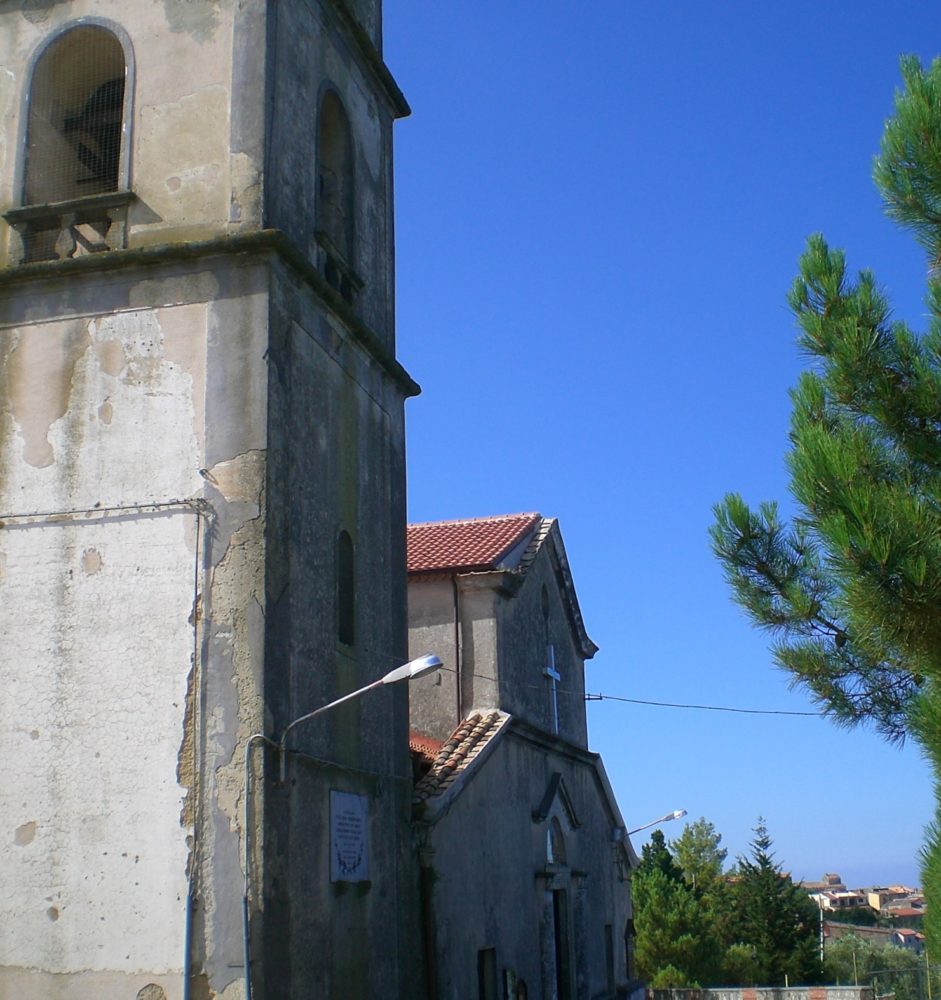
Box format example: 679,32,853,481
0,0,265,264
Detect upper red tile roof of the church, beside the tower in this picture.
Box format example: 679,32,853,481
406,514,542,573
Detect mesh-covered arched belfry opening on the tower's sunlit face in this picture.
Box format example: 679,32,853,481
24,26,127,205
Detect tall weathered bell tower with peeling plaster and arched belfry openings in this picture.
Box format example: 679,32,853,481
0,0,421,1000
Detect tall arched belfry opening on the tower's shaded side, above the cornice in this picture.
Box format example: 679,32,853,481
316,90,360,302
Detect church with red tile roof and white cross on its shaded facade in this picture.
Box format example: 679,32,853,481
408,514,640,1000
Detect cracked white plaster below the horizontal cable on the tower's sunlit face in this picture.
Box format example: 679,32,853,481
0,511,194,974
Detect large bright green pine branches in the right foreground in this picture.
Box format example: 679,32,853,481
712,58,941,956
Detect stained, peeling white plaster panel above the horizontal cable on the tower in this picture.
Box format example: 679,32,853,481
0,304,207,513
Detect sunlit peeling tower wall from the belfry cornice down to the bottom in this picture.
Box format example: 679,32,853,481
0,254,268,1000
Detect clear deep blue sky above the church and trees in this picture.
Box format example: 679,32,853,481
385,0,941,885
